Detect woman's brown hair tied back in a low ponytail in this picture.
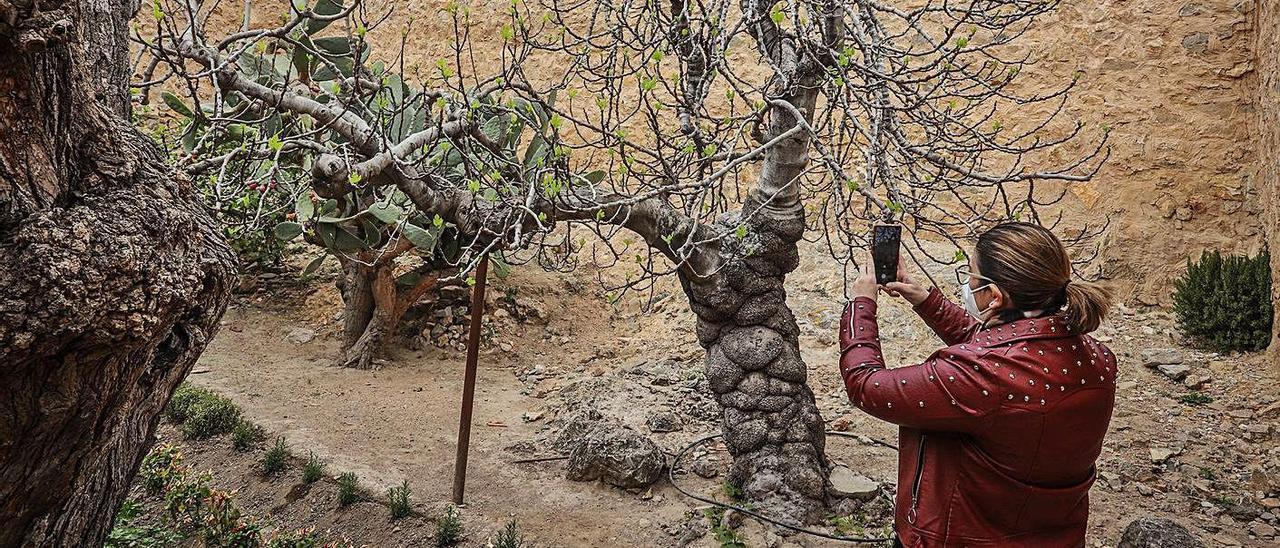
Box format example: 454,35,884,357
974,223,1111,333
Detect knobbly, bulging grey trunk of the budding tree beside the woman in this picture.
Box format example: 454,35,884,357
681,90,827,522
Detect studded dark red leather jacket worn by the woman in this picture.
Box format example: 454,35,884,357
840,288,1116,548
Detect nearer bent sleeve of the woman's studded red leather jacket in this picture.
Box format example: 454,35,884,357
840,297,1000,431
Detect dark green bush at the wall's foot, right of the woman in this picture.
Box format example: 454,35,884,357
1174,251,1272,352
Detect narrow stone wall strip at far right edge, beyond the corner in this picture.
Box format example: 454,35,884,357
1254,1,1280,355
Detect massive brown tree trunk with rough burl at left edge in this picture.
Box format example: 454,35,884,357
0,0,234,547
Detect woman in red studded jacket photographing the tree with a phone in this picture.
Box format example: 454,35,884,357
840,223,1116,547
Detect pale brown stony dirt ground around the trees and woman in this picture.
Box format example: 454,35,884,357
132,239,1280,547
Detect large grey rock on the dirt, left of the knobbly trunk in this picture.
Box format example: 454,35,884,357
566,424,667,489
